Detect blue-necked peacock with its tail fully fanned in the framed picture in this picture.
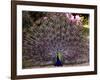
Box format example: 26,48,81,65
22,11,89,68
